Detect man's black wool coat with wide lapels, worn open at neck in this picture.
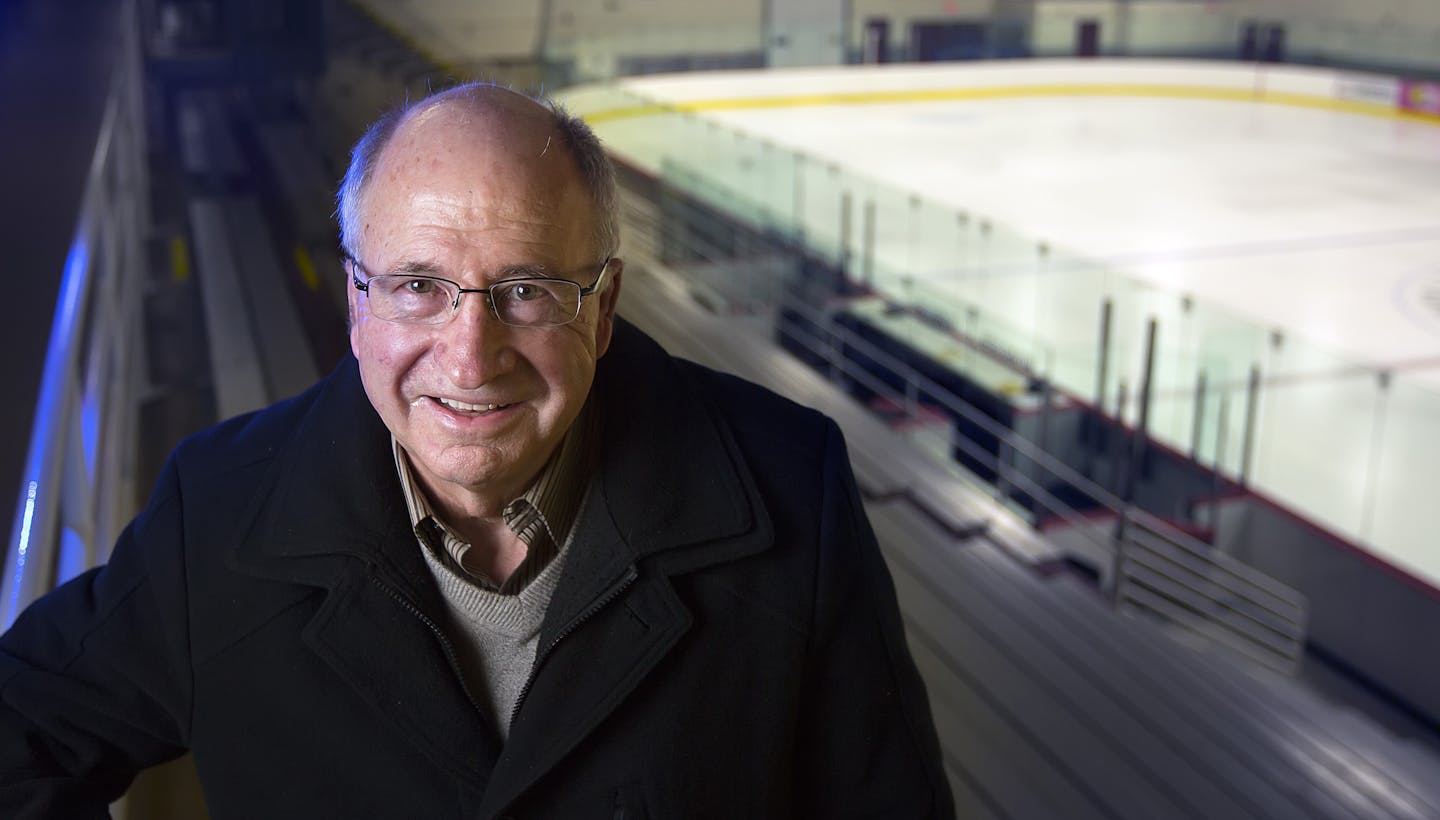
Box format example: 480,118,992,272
0,323,952,820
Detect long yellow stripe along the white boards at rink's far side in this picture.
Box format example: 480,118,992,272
585,84,1430,122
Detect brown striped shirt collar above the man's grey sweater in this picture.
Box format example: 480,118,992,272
390,405,596,595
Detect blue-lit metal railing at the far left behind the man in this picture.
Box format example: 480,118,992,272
0,1,148,628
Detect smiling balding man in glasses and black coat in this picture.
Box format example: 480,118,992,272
0,85,952,820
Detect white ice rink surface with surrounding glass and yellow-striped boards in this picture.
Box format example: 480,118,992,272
558,61,1440,585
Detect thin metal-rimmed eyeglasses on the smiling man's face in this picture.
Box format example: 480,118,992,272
350,258,613,327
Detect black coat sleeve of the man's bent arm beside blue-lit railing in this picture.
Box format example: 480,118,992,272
0,464,190,820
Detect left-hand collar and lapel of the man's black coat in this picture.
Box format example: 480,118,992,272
233,356,500,793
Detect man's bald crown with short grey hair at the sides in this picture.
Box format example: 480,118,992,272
337,82,619,258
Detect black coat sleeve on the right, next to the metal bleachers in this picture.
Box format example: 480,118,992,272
799,424,955,820
